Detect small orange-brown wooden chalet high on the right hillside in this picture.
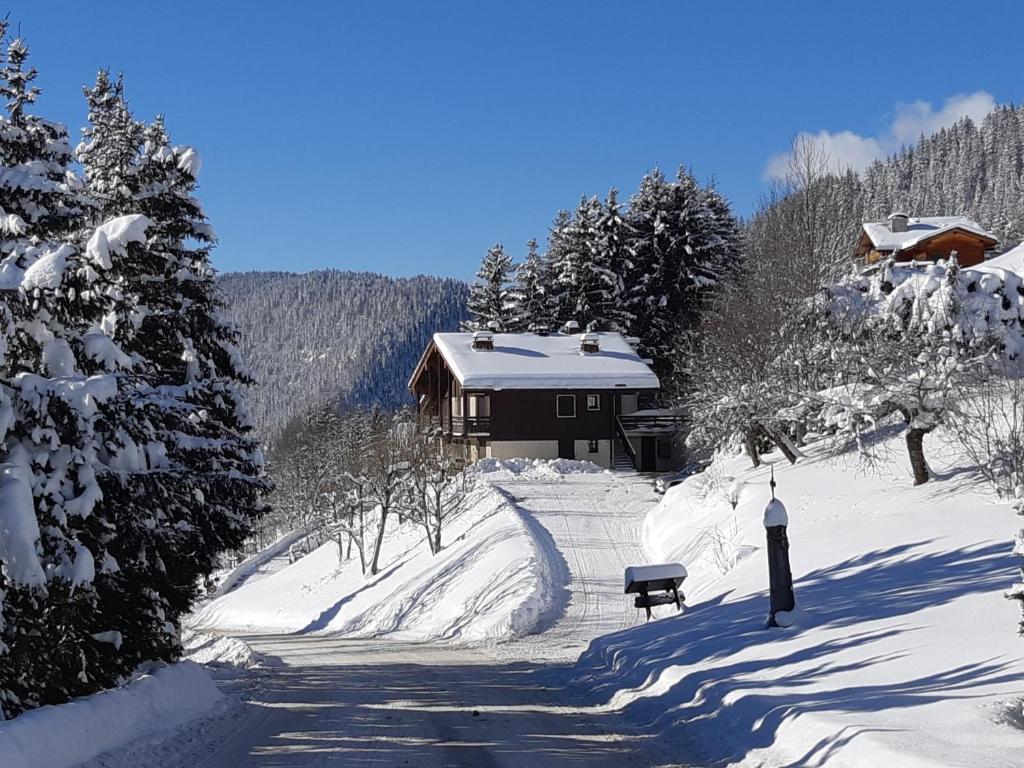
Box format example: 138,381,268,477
853,213,999,266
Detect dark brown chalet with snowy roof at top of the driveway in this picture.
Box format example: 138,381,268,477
409,331,681,471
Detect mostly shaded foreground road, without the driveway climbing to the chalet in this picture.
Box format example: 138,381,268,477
92,636,669,768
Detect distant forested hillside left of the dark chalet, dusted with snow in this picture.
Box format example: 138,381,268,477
219,270,467,440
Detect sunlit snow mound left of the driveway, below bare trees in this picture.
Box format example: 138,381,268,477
193,478,562,642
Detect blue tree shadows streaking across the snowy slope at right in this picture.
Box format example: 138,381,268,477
573,542,1019,765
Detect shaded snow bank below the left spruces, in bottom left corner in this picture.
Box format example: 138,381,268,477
0,662,221,768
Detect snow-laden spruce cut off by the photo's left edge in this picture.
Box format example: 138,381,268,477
0,22,115,717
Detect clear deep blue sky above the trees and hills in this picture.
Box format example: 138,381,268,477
8,0,1024,278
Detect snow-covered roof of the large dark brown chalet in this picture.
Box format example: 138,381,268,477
421,333,660,389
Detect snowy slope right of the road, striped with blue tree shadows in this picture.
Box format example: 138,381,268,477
573,430,1024,768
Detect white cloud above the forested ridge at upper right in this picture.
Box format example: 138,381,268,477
764,91,995,179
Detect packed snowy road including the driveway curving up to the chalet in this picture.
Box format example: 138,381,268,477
90,474,674,768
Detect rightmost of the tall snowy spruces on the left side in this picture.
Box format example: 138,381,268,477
127,121,267,622
